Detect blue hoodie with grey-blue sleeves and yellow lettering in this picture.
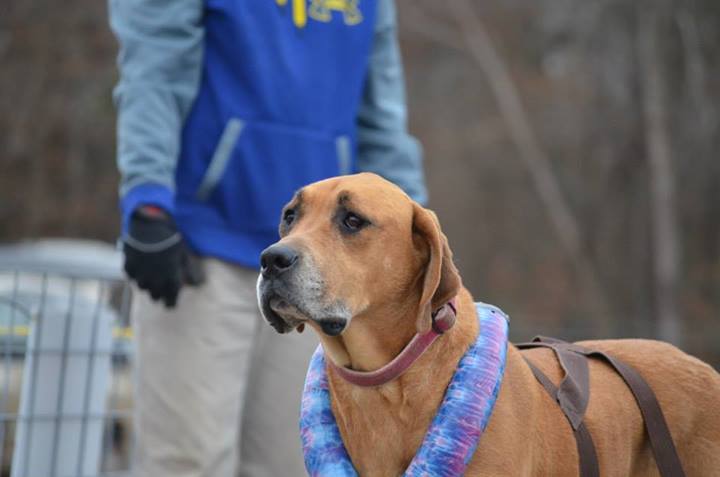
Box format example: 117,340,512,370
110,0,426,266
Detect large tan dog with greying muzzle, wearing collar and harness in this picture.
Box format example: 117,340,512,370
258,174,720,477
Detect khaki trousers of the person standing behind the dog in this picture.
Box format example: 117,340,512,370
133,259,317,477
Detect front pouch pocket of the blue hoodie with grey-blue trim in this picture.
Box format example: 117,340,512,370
196,118,352,232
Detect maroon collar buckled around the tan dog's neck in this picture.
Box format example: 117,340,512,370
327,298,457,387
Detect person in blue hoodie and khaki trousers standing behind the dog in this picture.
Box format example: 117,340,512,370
110,0,425,477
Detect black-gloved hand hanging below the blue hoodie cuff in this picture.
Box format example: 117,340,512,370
123,206,204,308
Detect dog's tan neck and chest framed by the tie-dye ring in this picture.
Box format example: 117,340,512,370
314,289,479,475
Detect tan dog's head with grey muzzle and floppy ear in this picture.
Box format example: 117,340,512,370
257,173,461,336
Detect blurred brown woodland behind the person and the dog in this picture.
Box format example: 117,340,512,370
0,0,720,366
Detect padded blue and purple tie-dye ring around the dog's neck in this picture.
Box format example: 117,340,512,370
300,303,508,477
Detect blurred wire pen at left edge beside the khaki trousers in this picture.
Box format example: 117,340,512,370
0,244,133,477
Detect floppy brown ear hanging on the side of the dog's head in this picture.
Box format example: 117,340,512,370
413,204,462,333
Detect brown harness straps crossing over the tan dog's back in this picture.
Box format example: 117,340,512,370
517,336,685,477
